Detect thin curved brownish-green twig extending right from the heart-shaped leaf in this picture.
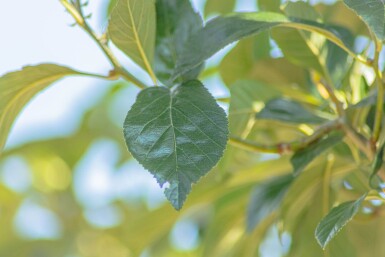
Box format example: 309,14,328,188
229,119,342,154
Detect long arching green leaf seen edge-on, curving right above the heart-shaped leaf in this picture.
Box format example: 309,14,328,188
173,12,356,79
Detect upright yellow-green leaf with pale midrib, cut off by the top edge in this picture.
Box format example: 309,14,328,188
108,0,156,82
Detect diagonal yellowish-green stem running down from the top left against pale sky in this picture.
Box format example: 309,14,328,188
60,0,147,89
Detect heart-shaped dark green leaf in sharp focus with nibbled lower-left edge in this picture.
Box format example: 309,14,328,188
124,80,228,210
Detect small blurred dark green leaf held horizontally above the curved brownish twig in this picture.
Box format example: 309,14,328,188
256,98,325,124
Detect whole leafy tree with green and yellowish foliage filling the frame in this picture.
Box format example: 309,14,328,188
0,0,385,256
